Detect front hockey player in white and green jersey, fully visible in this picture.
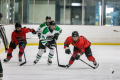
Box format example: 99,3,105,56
34,21,62,65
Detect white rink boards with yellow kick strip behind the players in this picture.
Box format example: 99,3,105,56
5,25,120,45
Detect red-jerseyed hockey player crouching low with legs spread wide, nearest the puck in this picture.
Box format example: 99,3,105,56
64,31,97,68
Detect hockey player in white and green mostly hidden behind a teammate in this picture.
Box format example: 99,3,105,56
37,16,51,52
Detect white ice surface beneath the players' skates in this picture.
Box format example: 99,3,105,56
0,45,120,80
